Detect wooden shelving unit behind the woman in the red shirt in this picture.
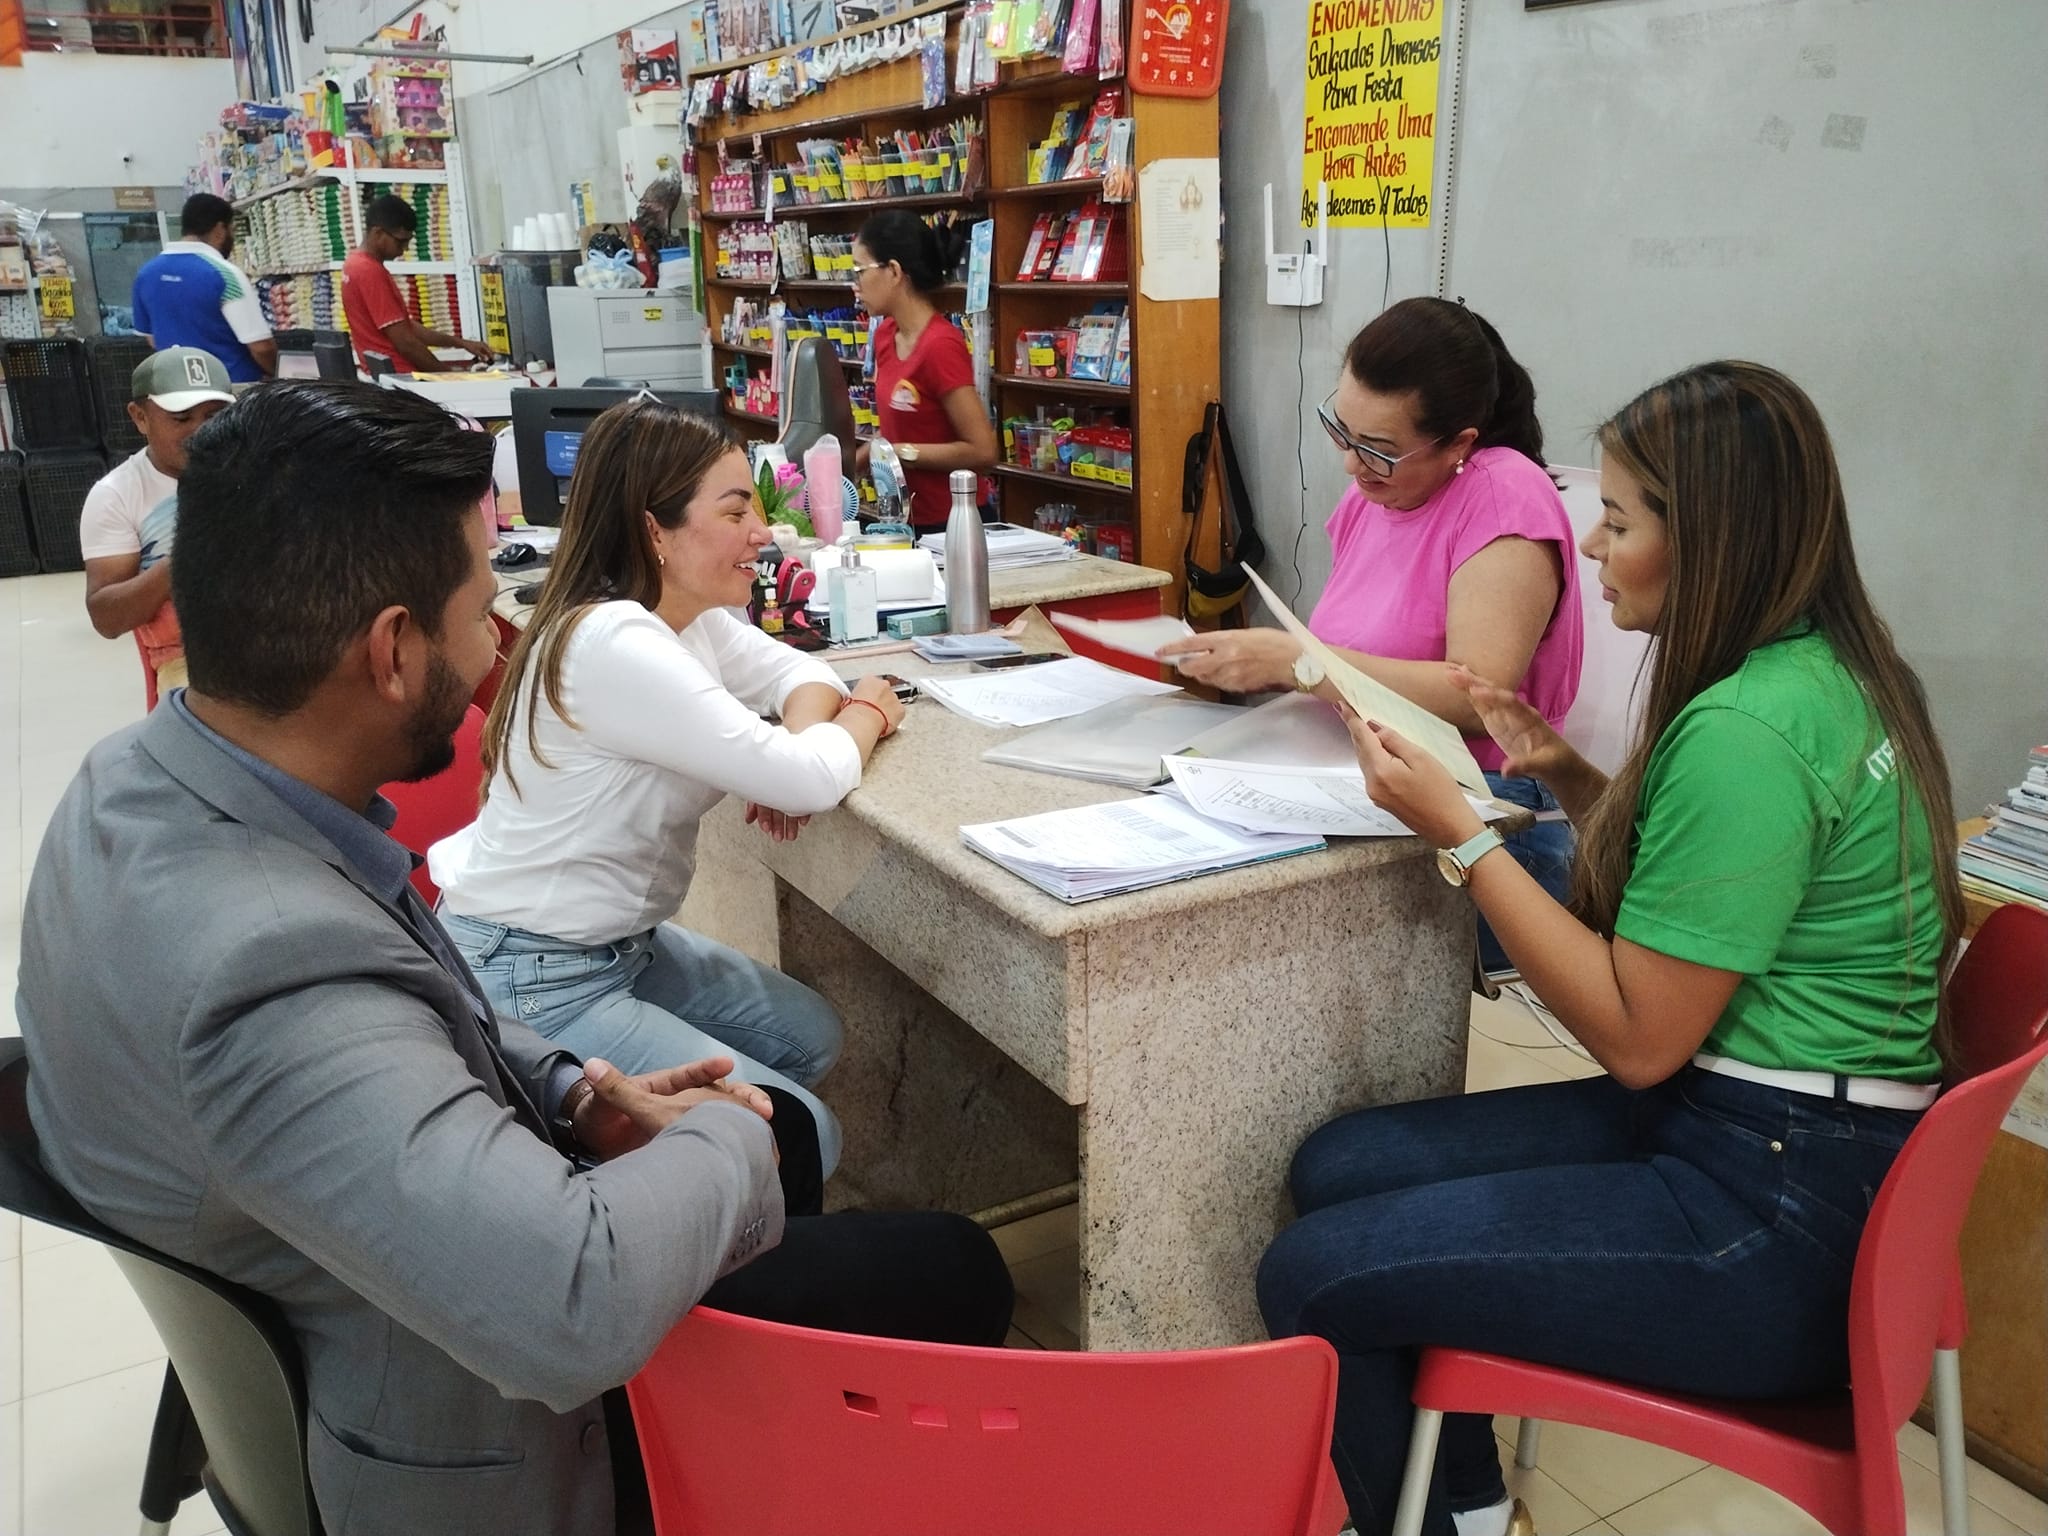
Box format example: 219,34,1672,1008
696,6,1221,608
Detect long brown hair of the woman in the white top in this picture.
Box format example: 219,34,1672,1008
483,395,739,795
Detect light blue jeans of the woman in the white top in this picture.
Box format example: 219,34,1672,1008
440,911,842,1178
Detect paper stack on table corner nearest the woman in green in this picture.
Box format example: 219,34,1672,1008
961,795,1325,901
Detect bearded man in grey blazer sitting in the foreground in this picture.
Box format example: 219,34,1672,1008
16,385,1008,1536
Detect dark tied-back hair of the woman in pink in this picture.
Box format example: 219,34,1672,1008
1343,299,1542,465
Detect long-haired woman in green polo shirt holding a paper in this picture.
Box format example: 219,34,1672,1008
1260,362,1962,1536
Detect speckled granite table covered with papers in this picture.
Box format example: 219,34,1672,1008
506,561,1473,1350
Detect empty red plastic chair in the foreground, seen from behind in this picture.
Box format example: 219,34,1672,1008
627,1307,1343,1536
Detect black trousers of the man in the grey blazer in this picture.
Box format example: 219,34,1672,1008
604,1087,1014,1536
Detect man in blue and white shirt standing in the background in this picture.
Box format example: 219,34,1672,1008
133,193,276,383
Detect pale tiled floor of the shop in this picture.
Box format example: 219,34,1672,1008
0,575,2048,1536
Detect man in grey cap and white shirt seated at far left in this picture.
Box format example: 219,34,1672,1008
78,346,233,690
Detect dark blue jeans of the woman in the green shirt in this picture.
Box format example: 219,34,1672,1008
1257,1065,1919,1536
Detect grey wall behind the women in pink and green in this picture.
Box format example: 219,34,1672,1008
1223,0,2048,813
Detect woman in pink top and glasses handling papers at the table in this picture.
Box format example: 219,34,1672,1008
1161,299,1583,971
